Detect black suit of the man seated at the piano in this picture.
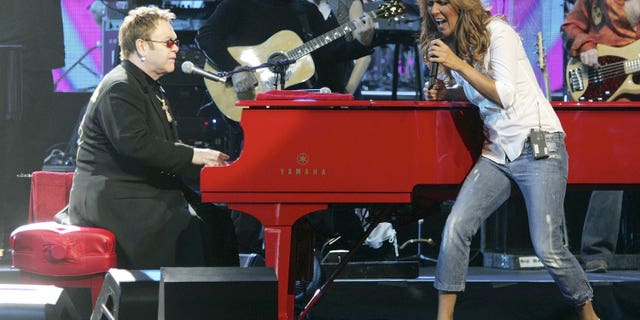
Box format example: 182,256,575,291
69,60,200,269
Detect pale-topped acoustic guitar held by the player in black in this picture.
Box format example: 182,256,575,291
204,0,405,121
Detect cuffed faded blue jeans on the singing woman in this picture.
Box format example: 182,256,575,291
434,133,593,306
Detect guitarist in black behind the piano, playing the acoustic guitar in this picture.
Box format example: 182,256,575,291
196,0,374,96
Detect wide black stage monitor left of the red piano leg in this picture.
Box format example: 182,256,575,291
158,267,278,320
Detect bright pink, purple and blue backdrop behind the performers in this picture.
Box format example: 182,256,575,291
54,0,564,91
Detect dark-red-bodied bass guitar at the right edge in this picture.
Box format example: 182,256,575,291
565,40,640,101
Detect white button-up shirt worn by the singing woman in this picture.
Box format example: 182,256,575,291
452,18,564,164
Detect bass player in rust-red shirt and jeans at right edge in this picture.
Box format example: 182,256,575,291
562,0,640,272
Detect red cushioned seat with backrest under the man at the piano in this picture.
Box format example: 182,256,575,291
9,171,116,306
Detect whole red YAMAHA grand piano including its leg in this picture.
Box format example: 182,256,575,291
200,100,640,319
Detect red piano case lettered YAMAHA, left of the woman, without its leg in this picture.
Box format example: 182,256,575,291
201,101,481,202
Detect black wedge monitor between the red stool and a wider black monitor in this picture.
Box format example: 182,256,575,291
91,269,160,320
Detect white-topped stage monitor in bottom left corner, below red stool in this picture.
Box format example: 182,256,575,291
0,284,82,320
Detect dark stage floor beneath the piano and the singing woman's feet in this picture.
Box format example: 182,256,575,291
0,265,640,320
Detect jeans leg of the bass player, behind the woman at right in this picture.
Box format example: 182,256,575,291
580,190,624,263
